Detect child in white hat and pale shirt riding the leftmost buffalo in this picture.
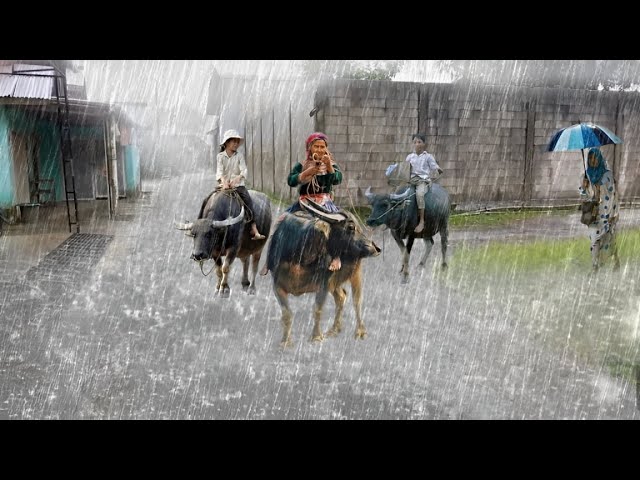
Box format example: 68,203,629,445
216,130,265,240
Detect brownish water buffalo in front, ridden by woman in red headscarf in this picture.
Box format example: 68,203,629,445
267,202,380,347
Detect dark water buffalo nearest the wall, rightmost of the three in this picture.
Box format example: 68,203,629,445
365,183,451,283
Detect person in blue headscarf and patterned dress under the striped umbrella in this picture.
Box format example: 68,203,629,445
582,147,620,272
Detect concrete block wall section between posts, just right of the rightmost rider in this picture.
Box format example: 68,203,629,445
422,84,527,203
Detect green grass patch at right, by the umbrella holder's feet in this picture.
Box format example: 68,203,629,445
447,228,640,388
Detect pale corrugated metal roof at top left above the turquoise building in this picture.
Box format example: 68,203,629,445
0,64,53,100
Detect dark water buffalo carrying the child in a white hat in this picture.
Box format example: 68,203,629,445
177,190,271,297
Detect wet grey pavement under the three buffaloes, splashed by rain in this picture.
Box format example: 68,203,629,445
0,169,640,419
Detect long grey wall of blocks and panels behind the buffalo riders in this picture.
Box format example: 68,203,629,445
241,79,640,207
